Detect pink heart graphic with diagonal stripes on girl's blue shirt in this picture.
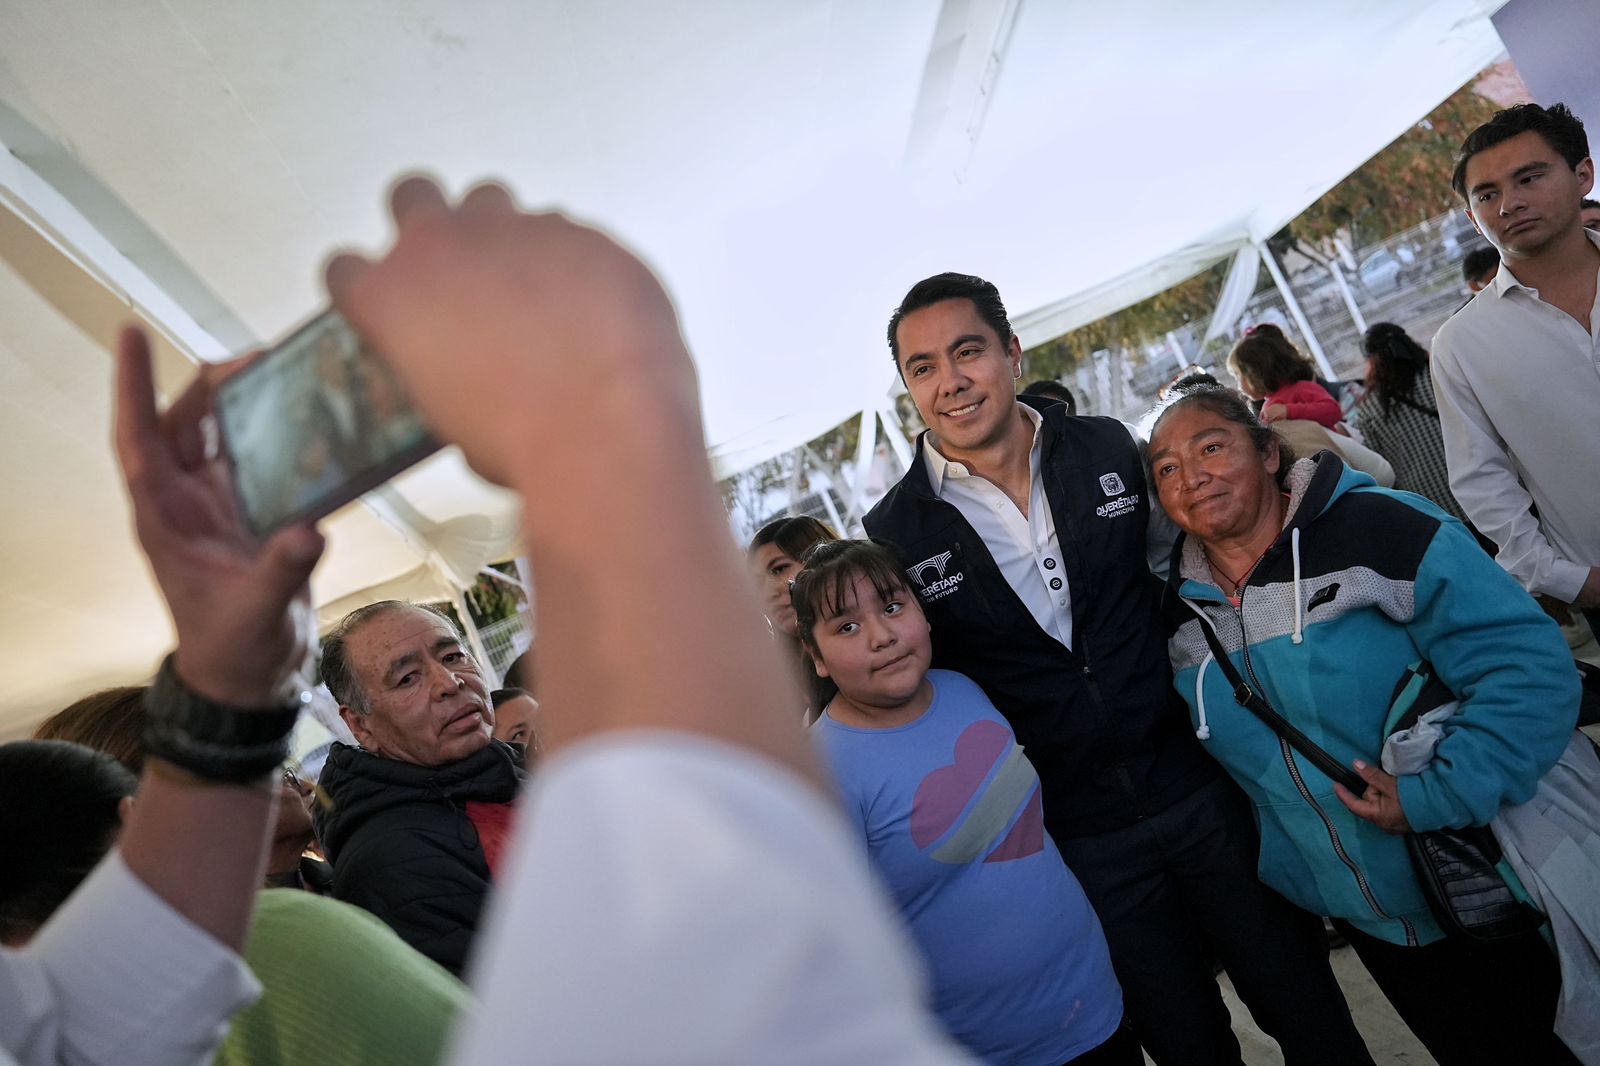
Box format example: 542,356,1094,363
910,722,1045,864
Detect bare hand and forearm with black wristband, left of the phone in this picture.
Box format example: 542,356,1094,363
115,328,322,951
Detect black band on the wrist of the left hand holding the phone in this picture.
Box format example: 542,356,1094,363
144,655,310,783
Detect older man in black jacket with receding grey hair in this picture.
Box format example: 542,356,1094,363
307,600,522,975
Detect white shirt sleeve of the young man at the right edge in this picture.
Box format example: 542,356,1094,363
1429,344,1589,603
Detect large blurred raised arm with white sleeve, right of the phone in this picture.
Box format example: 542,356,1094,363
328,179,968,1066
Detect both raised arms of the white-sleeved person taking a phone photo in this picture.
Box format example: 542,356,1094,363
0,179,971,1066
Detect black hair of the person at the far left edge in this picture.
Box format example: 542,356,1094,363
0,741,139,944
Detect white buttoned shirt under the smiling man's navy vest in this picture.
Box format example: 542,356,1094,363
922,403,1072,648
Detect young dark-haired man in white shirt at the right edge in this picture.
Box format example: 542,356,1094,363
1432,104,1600,623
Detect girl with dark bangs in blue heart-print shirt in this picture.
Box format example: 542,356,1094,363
792,541,1144,1066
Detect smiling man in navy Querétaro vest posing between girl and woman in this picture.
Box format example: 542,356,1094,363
866,274,1371,1064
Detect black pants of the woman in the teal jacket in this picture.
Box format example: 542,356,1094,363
1333,919,1578,1066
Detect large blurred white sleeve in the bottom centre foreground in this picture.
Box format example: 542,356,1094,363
451,731,971,1066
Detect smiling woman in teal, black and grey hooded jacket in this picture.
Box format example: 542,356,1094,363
1149,389,1579,1066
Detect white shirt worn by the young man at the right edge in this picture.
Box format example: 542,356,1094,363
1432,234,1600,602
